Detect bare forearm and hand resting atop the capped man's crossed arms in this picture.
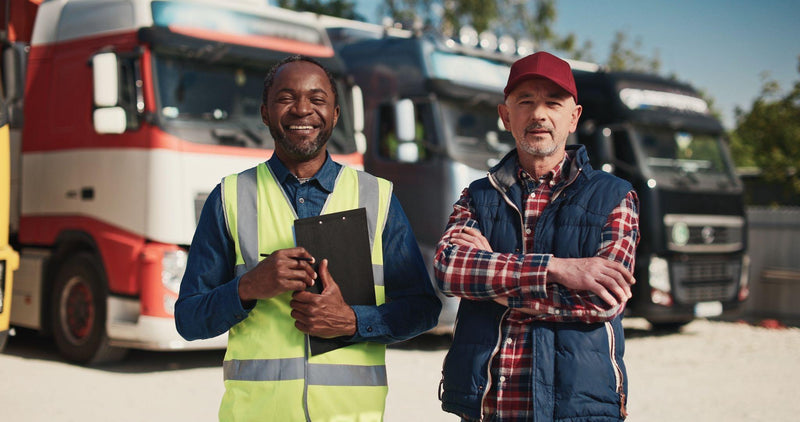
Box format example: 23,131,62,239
547,257,636,306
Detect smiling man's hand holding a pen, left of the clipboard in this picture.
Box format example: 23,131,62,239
239,247,317,302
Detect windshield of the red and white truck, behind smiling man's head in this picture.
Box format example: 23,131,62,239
153,54,355,153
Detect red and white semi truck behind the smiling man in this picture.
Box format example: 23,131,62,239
0,0,363,363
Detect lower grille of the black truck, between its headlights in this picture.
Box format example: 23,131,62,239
672,257,741,304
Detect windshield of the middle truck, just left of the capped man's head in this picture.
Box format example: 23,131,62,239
441,101,514,170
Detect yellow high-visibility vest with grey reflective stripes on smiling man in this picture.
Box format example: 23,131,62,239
219,163,391,422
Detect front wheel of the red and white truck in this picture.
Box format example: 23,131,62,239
50,252,127,365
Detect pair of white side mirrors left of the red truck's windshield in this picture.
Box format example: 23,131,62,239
92,52,127,134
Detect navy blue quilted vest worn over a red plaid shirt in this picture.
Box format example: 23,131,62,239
441,146,632,422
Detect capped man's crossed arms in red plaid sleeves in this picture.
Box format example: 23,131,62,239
434,190,639,323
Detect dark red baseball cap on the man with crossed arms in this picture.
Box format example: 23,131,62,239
503,51,578,103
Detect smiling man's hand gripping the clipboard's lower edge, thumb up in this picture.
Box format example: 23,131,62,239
289,259,356,338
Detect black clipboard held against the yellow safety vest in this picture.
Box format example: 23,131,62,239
294,208,375,356
